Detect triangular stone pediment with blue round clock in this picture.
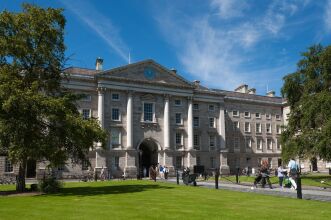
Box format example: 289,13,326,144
98,60,193,87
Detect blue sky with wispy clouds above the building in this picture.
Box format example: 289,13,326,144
0,0,331,95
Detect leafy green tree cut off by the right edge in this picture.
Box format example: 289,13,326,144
282,45,331,161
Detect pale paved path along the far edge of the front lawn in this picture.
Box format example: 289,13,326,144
164,178,331,202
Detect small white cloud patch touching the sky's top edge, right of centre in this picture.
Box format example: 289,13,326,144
211,0,248,19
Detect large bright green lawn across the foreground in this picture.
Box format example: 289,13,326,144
0,180,331,220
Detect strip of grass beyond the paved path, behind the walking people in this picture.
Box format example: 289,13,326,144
220,173,331,188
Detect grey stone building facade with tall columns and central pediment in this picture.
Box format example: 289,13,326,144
0,59,330,177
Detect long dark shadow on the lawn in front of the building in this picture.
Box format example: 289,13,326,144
53,185,174,196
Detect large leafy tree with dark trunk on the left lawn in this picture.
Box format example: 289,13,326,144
0,4,105,191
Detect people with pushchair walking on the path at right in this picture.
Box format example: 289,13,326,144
254,158,299,190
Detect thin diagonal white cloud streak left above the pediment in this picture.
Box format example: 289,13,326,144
61,0,129,62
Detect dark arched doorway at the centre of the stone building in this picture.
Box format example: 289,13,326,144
138,139,158,178
